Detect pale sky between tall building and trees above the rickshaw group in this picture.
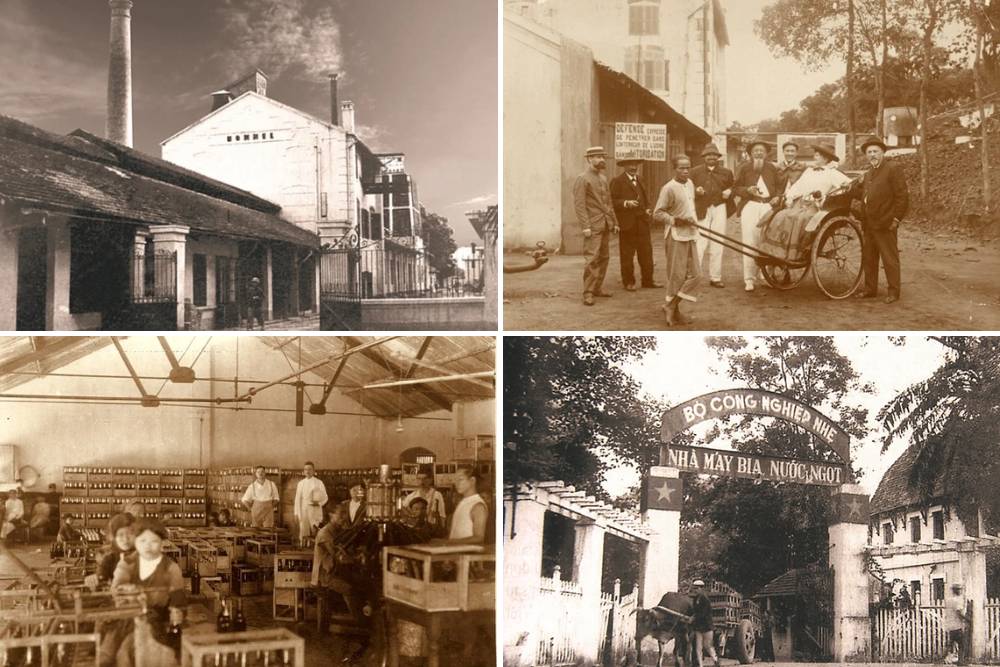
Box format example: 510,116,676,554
725,0,844,125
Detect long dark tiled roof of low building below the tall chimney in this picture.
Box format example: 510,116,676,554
0,116,319,247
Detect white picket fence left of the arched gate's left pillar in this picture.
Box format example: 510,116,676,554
534,567,639,667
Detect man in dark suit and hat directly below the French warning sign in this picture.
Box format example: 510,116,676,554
610,160,662,292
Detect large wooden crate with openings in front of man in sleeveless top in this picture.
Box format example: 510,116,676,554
382,545,496,611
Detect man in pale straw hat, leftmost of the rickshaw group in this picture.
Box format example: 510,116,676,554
573,146,618,306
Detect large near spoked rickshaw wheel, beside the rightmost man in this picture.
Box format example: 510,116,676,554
811,215,863,299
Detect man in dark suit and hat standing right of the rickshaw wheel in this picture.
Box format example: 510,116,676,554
853,137,910,303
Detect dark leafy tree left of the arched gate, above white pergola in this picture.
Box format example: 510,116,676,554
503,336,659,498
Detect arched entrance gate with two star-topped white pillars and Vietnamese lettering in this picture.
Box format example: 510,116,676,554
641,389,870,662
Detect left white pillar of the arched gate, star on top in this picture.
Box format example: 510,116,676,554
639,466,682,609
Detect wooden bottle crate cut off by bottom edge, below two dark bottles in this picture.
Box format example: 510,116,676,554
181,628,306,667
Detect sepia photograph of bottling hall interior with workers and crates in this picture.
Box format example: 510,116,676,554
0,335,496,667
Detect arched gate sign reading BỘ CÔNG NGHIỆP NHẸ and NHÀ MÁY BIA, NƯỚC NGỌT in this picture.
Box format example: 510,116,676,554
660,389,852,486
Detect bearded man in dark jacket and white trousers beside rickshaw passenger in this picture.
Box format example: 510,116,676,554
733,139,785,292
